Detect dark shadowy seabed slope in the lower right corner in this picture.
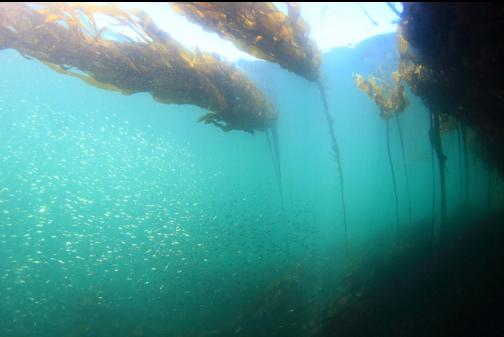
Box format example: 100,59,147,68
317,212,504,337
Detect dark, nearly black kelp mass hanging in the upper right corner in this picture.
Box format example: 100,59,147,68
400,3,504,172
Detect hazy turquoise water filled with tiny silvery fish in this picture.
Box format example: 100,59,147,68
0,35,502,337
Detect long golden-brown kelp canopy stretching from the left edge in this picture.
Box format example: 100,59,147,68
0,3,276,132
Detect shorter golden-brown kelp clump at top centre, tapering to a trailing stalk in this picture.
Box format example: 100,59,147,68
172,2,321,81
